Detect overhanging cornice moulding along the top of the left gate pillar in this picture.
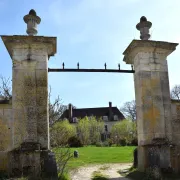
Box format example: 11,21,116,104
1,35,57,58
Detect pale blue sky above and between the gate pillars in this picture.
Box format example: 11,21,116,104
0,0,180,108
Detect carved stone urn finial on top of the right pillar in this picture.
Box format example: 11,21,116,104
136,16,152,40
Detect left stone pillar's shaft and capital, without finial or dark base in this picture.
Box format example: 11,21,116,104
2,36,56,149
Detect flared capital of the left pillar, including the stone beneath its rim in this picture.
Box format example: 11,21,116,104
1,35,56,59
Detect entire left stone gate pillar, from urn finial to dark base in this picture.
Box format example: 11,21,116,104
1,10,56,179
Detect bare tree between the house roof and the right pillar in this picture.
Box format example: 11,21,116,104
120,100,136,121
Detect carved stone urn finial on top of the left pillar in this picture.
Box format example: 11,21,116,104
24,9,41,36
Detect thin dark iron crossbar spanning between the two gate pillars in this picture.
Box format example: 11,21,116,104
48,68,135,73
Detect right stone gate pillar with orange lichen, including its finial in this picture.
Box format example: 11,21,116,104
123,17,178,171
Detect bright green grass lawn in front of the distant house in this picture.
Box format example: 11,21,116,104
54,146,136,169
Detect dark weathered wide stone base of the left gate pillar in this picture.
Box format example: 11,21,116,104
8,146,58,180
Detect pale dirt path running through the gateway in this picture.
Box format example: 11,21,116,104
70,163,132,180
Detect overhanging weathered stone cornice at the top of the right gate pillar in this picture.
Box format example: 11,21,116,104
123,40,178,64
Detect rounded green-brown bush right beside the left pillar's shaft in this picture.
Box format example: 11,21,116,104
50,120,76,146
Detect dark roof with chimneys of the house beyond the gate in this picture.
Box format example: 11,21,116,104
61,102,125,131
